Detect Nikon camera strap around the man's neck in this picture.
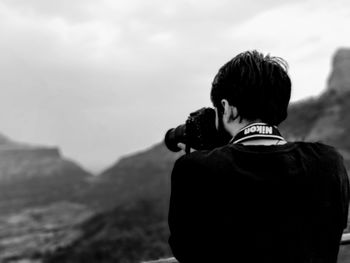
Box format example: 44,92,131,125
230,122,286,143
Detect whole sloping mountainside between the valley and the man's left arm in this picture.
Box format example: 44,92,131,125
44,144,179,263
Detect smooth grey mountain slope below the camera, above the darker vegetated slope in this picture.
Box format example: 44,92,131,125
81,143,179,214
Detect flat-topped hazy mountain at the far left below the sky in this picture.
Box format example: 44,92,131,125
0,135,91,215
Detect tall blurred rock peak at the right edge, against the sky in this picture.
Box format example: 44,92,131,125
328,48,350,93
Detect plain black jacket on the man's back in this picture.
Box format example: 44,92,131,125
169,142,349,263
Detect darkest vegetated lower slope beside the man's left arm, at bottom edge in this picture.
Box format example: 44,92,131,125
44,200,170,263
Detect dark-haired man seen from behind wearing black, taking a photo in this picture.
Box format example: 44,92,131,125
169,51,349,263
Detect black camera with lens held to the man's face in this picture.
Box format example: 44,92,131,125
164,108,227,152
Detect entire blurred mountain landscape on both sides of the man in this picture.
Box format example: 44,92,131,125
0,49,350,263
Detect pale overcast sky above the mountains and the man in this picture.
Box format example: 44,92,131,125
0,0,350,173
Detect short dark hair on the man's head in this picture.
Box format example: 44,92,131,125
210,50,291,125
